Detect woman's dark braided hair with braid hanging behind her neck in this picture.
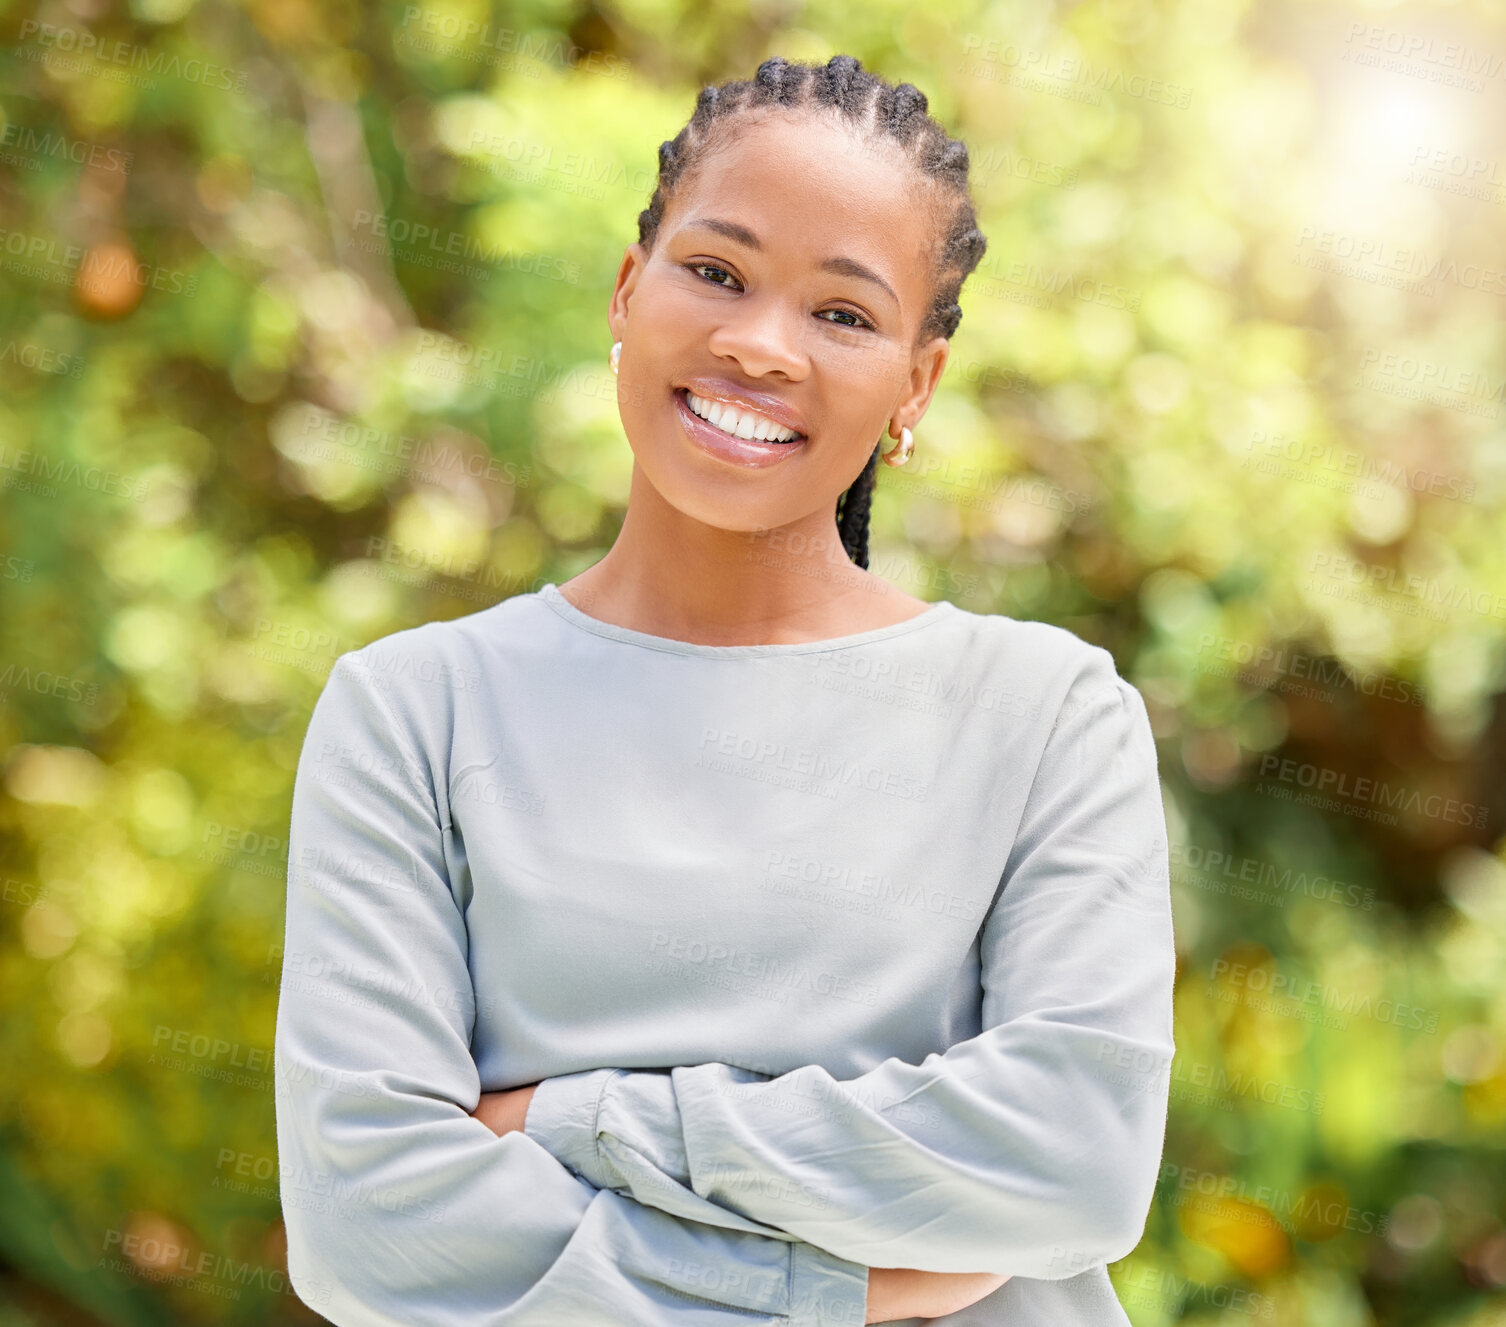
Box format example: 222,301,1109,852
639,56,988,569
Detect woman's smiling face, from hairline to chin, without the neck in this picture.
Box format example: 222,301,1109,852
608,113,947,532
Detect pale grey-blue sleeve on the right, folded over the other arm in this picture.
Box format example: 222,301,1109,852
526,646,1176,1280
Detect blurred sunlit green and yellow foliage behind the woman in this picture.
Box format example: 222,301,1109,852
0,0,1506,1327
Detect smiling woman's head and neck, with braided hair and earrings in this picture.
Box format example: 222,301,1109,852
581,56,986,642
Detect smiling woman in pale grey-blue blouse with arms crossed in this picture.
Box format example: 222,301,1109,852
276,56,1175,1327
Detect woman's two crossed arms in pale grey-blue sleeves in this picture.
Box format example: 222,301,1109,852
274,651,1175,1327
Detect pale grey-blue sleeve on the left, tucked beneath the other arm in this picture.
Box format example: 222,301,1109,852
274,652,867,1327
